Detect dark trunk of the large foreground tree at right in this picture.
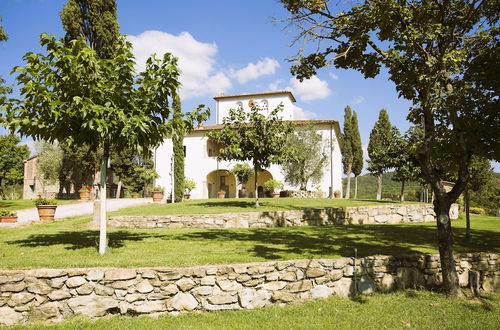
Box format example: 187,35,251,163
434,194,460,296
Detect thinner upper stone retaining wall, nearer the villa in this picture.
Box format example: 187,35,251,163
108,204,458,228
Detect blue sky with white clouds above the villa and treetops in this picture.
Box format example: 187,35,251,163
0,0,500,171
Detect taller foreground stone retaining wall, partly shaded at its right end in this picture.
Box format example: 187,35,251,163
0,253,500,324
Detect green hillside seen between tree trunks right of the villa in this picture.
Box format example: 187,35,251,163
343,172,420,201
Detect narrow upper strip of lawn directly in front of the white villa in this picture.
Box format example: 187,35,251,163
111,198,415,216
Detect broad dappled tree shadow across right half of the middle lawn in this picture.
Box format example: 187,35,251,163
169,225,500,260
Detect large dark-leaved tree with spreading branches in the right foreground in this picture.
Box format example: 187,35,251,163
281,0,500,294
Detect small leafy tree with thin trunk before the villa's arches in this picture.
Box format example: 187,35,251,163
207,104,293,206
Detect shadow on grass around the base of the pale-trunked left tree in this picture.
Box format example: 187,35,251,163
6,230,165,250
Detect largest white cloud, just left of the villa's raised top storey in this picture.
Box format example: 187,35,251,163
127,31,231,99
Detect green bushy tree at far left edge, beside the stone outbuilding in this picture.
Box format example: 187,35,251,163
0,134,30,193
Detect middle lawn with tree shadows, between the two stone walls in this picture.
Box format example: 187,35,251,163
0,216,500,269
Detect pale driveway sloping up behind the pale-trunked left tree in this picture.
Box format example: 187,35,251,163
0,198,153,227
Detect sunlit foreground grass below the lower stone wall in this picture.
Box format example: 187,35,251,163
9,290,500,330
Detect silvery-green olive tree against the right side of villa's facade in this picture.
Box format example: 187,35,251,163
281,125,328,190
